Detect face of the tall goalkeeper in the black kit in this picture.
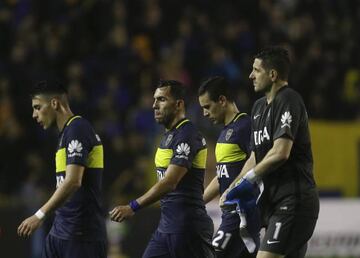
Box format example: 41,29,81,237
249,58,272,92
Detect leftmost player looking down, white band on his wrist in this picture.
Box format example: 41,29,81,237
17,81,107,258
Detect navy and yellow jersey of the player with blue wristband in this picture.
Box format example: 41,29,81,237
155,119,213,233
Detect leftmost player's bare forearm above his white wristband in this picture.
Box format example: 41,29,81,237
40,180,80,214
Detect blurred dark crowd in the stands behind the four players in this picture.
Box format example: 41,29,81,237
0,0,360,242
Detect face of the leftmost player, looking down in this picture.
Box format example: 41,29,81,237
32,95,56,130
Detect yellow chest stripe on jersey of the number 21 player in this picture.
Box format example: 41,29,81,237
215,143,246,163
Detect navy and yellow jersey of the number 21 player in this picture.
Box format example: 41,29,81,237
215,113,251,230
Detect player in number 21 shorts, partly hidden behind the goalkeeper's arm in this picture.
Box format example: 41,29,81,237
198,77,260,258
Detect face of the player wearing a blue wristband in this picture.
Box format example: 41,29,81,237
153,87,177,128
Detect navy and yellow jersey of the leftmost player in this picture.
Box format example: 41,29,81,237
50,116,106,241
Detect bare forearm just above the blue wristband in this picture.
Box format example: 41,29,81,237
136,179,176,207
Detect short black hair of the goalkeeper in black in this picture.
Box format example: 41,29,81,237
255,46,290,80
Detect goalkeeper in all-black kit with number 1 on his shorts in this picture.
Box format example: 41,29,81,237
222,47,319,258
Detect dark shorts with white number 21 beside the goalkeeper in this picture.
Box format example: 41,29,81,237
212,210,260,258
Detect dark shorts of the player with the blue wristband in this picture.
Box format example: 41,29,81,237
143,230,215,258
